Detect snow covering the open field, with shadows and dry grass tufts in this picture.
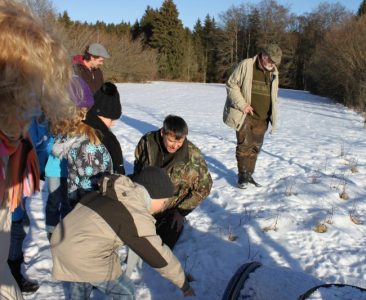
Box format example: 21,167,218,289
24,82,366,300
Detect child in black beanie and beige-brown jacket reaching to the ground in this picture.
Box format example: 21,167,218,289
51,167,194,299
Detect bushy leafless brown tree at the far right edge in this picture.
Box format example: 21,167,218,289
308,16,366,111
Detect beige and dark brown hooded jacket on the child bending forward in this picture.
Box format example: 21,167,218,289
51,175,189,290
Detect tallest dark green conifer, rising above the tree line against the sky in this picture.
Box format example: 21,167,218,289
151,0,184,79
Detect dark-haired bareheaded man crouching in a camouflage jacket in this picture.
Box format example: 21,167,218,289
134,115,212,249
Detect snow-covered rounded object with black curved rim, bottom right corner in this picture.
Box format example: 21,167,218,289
222,262,366,300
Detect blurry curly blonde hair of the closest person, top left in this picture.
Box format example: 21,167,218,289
0,0,75,134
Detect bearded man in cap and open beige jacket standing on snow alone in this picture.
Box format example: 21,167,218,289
223,44,282,189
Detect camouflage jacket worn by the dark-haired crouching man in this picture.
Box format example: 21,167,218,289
134,130,212,216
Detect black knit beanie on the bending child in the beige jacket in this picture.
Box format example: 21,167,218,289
131,167,174,199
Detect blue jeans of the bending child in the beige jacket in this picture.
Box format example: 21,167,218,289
70,274,136,300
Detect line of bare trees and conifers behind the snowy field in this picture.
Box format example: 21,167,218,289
24,0,366,112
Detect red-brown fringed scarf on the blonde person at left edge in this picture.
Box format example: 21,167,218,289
0,131,40,212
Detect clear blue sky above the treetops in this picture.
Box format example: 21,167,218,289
53,0,362,29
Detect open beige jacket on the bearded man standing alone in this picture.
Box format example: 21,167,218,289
223,56,279,132
